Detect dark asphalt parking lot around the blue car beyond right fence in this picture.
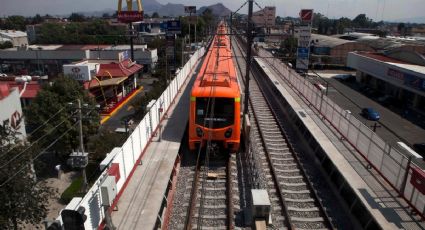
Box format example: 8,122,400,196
308,72,425,152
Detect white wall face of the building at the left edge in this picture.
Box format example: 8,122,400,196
0,88,26,139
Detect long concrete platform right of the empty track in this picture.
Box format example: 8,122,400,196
255,56,425,229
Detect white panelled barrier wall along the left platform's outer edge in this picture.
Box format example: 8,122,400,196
52,48,205,229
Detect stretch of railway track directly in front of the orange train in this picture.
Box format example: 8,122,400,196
185,148,236,229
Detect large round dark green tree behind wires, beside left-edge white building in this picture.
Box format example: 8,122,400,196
24,77,99,160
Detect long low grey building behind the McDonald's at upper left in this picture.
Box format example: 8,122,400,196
0,45,158,76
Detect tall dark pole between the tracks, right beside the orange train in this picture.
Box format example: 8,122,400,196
243,0,254,124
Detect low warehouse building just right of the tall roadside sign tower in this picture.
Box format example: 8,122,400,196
310,34,374,66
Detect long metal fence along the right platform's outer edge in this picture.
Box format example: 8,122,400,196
255,49,425,217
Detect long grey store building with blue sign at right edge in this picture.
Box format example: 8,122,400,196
347,51,425,114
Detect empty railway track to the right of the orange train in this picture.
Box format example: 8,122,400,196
235,35,333,229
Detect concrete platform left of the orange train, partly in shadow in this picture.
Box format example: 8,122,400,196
111,63,199,229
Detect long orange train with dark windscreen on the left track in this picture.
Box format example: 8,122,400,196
189,22,241,152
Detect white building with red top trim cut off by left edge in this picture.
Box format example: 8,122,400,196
0,84,26,140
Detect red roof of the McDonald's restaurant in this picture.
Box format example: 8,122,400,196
96,60,142,78
